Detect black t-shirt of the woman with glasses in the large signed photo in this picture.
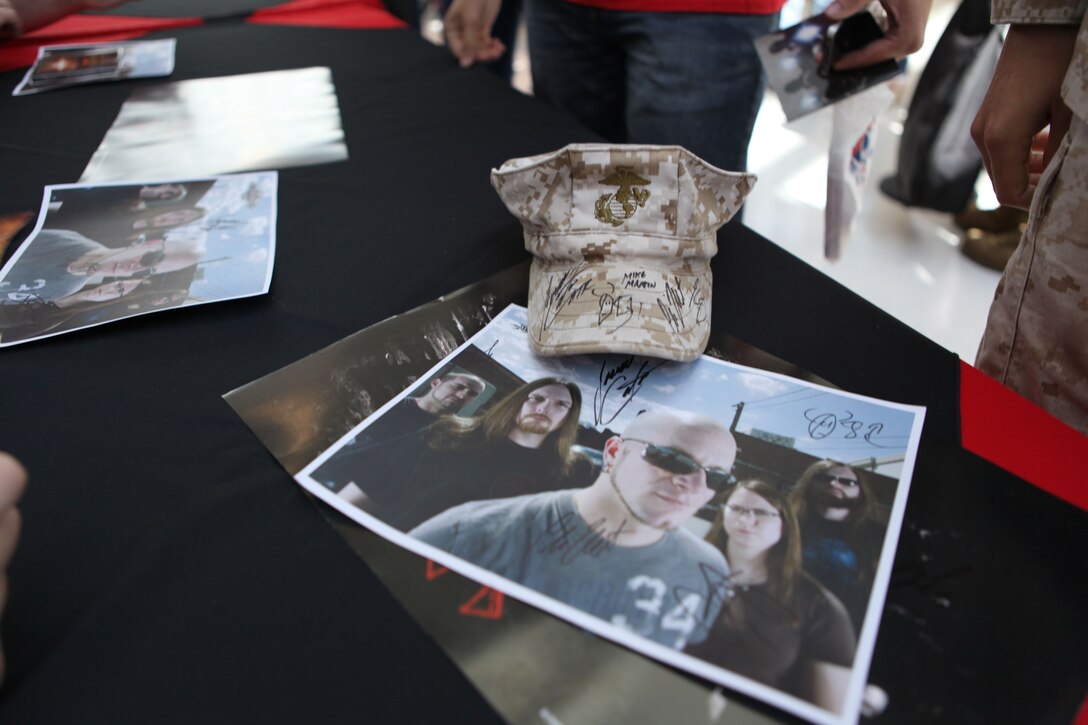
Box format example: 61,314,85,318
688,574,856,693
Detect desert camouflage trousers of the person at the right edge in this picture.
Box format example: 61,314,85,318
975,115,1088,433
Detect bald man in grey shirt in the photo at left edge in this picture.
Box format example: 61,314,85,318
0,229,203,302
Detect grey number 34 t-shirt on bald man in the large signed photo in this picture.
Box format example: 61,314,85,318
410,490,729,650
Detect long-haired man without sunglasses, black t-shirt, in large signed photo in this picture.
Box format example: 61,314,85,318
311,378,593,531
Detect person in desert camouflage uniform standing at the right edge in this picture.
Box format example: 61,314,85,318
972,0,1088,434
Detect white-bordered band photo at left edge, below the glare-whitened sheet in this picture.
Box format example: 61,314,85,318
0,171,277,347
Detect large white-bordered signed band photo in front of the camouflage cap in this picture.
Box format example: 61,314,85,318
297,307,924,723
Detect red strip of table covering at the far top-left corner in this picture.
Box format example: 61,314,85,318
0,15,203,72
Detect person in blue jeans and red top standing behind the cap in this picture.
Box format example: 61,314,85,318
445,0,931,171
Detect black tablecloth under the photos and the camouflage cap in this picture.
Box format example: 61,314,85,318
0,19,1088,723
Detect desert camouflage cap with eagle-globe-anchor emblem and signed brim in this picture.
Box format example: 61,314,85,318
491,144,755,361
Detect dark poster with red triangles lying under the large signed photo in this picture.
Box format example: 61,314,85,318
224,261,828,725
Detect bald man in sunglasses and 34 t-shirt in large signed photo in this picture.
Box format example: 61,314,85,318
410,411,737,650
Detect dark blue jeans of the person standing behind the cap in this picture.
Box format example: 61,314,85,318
527,0,778,171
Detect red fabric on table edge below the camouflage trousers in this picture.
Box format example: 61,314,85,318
960,361,1088,507
